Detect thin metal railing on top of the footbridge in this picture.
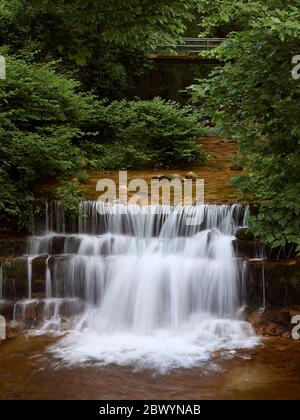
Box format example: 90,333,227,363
156,38,227,54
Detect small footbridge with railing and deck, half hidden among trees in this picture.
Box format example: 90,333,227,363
150,38,227,61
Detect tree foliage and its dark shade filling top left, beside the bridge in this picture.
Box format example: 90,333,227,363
0,0,196,99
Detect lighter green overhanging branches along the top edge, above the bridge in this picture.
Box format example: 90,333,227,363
23,0,195,56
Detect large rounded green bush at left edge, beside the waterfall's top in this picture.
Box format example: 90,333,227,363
0,56,93,228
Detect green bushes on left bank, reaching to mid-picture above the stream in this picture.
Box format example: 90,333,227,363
0,54,206,228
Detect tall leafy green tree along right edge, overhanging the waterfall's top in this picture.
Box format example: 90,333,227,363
192,0,300,249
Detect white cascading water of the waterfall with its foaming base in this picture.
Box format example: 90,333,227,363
12,202,256,371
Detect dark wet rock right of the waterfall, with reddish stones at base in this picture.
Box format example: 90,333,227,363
243,261,300,338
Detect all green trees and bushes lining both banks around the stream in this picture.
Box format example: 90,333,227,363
0,0,300,253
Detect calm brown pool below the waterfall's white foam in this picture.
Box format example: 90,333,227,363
0,335,300,400
